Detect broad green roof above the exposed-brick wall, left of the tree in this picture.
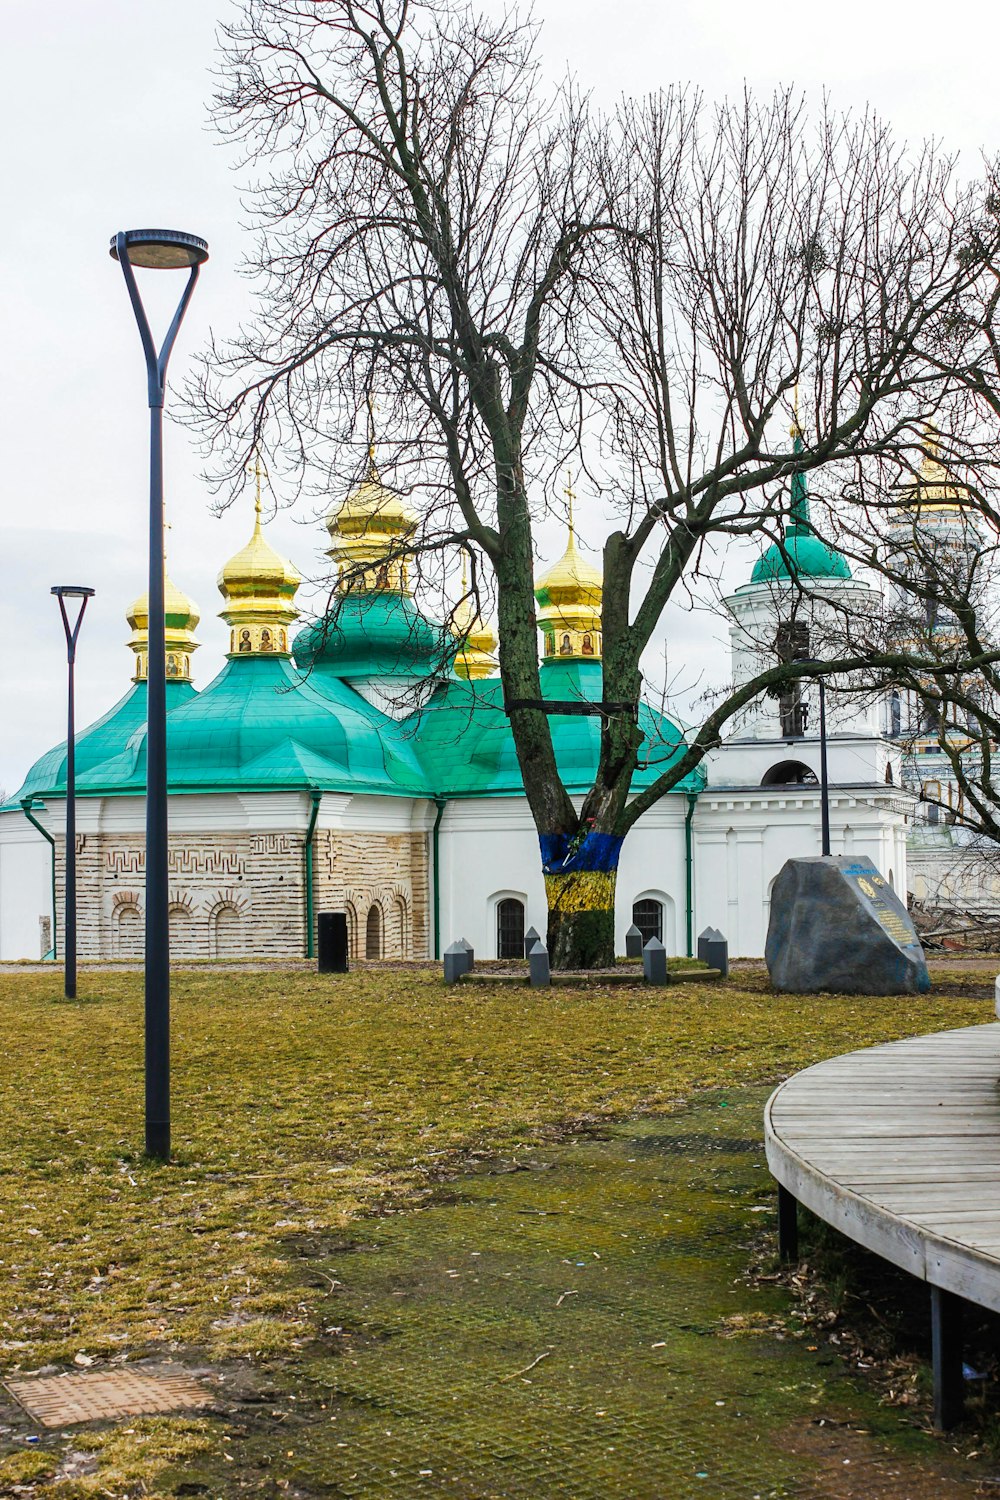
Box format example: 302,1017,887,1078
76,656,426,797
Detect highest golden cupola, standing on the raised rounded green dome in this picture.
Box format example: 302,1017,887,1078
327,455,417,594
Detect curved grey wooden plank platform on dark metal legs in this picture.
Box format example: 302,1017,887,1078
765,1022,1000,1430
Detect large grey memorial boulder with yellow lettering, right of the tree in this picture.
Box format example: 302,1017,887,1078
765,855,931,995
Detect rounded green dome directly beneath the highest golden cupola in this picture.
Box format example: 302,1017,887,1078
292,591,459,680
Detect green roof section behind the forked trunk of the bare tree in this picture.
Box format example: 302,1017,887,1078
406,659,705,797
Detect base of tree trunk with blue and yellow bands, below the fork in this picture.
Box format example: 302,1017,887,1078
538,833,622,969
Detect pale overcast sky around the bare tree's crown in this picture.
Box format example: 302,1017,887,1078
0,0,1000,794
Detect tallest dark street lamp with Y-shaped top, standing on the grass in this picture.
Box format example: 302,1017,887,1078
111,230,208,1161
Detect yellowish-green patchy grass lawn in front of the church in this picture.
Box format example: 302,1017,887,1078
0,969,993,1500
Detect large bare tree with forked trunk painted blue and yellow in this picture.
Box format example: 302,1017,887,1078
192,0,1000,966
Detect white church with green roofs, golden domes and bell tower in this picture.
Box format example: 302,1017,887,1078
0,450,915,960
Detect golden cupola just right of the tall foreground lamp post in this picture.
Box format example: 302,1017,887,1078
219,498,301,656
